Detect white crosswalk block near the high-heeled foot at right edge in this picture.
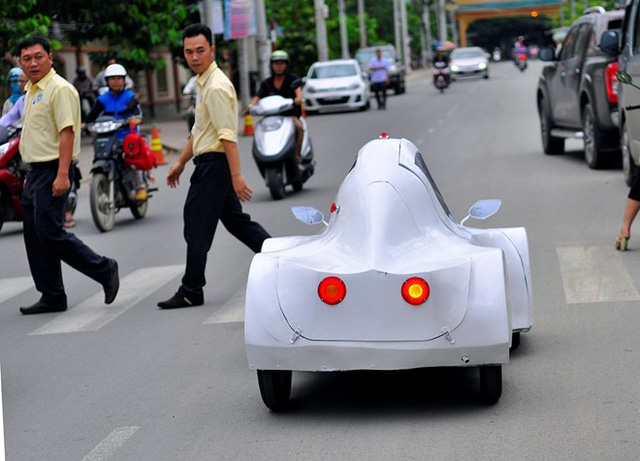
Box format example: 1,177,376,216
556,246,640,304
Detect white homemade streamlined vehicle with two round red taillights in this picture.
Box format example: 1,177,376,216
245,136,532,411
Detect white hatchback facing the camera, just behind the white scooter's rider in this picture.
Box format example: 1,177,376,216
302,59,370,113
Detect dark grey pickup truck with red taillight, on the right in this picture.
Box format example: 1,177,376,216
537,6,624,168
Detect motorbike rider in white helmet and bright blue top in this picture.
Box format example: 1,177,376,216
87,64,148,201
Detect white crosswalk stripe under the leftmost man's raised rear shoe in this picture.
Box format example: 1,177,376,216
29,265,184,335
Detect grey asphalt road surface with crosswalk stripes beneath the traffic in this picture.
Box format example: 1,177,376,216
0,62,640,461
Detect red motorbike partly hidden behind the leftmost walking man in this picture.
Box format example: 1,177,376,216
0,126,27,229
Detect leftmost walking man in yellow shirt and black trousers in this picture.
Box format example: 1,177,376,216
17,37,120,315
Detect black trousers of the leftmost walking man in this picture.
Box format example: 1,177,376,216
22,161,111,306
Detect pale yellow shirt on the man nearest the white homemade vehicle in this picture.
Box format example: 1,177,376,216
191,61,238,155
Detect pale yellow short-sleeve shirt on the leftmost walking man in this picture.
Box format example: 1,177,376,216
20,69,80,163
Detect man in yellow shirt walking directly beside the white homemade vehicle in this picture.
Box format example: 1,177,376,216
158,24,270,309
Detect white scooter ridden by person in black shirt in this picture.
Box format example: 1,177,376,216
250,95,315,200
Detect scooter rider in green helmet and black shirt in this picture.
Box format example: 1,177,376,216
247,50,304,163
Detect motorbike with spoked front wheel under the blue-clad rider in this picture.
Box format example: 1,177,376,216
87,117,158,232
